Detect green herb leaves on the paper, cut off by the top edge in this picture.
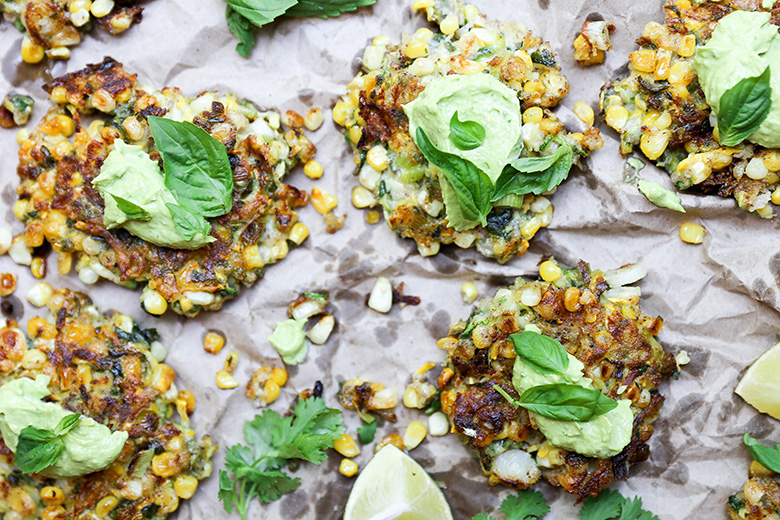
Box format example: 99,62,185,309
225,0,376,58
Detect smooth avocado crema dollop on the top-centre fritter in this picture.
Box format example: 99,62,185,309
403,73,521,183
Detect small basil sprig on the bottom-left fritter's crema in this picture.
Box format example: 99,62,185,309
14,413,81,473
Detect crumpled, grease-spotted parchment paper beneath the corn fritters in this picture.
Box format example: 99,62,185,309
0,0,780,520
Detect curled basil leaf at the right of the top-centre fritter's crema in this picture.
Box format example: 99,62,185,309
490,142,574,202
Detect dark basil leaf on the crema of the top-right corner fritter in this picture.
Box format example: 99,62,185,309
718,66,772,146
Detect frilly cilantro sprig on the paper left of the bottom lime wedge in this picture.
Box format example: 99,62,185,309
219,397,345,520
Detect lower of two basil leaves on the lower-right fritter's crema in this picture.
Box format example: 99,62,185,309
520,383,617,421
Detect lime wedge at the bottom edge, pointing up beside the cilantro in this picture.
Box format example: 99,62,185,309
344,444,452,520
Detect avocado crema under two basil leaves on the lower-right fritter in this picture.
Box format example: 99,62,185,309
512,354,634,458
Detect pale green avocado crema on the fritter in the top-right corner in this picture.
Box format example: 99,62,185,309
693,11,780,148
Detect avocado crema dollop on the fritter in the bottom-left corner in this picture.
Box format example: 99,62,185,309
0,375,128,478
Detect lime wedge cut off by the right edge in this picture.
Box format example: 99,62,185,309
734,343,780,419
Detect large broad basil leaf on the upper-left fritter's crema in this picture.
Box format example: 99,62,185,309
147,116,233,217
